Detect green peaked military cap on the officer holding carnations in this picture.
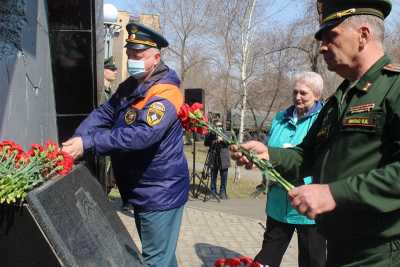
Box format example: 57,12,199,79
315,0,392,40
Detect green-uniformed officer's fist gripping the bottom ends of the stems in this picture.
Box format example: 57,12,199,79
288,184,336,219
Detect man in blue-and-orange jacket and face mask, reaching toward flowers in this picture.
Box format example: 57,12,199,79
63,23,189,267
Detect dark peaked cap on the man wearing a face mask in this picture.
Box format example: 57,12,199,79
125,22,169,50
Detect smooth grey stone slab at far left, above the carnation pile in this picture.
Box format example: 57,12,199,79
0,0,57,146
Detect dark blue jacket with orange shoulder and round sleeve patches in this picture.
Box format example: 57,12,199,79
75,62,189,211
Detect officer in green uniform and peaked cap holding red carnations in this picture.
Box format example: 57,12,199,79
231,0,400,267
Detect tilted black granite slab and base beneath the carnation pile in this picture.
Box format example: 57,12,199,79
0,165,145,267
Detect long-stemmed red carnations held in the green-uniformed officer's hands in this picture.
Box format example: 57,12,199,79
178,103,294,191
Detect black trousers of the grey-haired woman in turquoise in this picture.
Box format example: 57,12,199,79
255,217,326,267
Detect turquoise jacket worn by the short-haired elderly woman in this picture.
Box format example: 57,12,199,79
266,102,322,224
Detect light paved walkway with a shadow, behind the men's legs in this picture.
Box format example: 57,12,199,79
111,199,298,267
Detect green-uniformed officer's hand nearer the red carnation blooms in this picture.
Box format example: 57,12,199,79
229,141,269,169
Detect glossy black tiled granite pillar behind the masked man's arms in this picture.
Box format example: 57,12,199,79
48,0,104,141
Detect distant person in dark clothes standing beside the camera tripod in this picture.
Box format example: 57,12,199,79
204,120,231,199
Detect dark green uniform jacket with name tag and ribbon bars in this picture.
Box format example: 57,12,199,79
269,56,400,242
